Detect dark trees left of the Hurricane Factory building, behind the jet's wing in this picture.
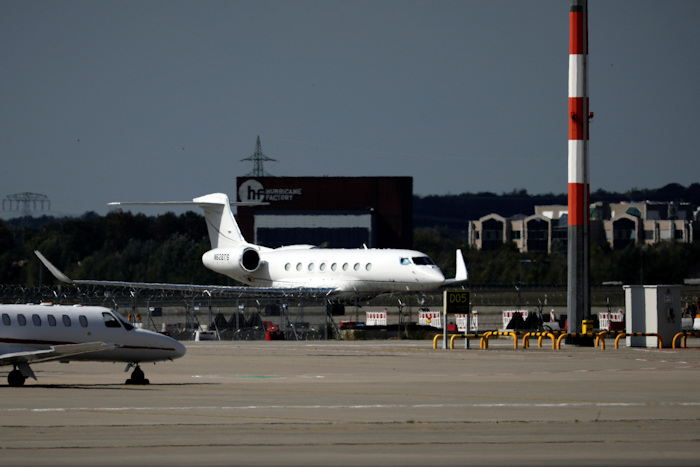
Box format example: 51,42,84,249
0,211,229,286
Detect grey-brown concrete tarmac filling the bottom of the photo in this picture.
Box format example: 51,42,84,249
0,338,700,466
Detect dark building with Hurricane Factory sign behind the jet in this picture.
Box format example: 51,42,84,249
236,176,413,248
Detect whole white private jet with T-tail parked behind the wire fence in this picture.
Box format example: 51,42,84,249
35,193,468,299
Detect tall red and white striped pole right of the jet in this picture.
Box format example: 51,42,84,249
567,0,590,333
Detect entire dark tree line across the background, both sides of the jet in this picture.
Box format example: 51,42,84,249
0,184,700,286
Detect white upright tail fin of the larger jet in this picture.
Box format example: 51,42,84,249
192,193,248,249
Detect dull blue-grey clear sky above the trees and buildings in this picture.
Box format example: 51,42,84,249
0,0,700,218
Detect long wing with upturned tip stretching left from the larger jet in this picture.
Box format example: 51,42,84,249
34,250,338,297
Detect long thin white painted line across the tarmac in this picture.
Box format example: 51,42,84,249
0,402,700,413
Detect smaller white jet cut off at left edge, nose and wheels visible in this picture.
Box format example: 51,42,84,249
0,304,186,387
